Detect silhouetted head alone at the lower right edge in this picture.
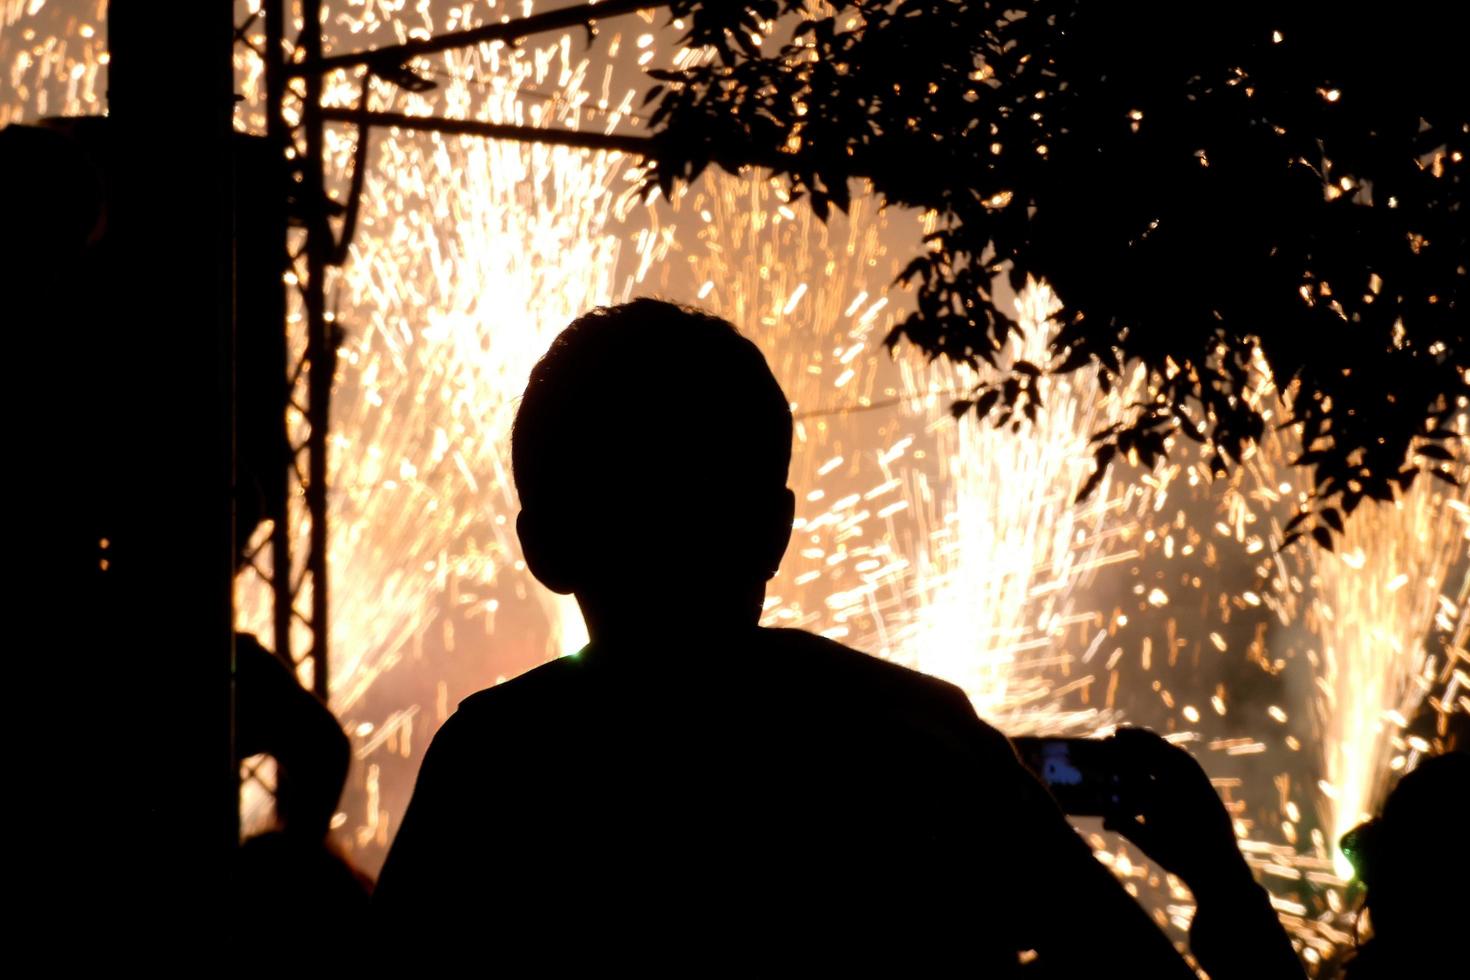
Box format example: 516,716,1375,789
1344,751,1470,948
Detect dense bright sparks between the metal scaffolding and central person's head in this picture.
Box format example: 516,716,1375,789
229,3,631,702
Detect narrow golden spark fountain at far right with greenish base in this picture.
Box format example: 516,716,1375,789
1233,364,1470,879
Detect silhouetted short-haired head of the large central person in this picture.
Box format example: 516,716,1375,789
512,298,794,636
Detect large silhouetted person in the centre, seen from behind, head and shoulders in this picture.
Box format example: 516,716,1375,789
375,300,1192,977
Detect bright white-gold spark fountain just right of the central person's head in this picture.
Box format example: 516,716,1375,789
892,284,1136,733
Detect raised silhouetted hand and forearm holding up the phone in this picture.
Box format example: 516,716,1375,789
1104,729,1305,980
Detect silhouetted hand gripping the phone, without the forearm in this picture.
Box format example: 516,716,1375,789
1103,729,1252,896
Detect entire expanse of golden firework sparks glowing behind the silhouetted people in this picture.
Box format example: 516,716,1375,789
0,7,1470,962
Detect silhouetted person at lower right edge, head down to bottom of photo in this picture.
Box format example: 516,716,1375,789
1342,742,1470,980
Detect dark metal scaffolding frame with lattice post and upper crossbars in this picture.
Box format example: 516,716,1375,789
235,0,663,805
